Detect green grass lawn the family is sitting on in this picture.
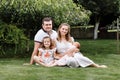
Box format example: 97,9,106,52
0,40,120,80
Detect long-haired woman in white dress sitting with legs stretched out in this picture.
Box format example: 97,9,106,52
52,23,107,68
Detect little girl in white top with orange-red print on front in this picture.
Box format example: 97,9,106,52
33,36,56,67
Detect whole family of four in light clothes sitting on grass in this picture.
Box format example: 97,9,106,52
23,17,107,68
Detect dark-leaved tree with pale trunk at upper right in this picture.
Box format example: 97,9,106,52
73,0,120,39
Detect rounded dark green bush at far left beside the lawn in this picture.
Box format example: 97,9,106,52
0,22,28,57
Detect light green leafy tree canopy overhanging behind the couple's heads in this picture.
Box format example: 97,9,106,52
0,0,91,31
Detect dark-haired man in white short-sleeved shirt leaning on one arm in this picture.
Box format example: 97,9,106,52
30,17,57,64
